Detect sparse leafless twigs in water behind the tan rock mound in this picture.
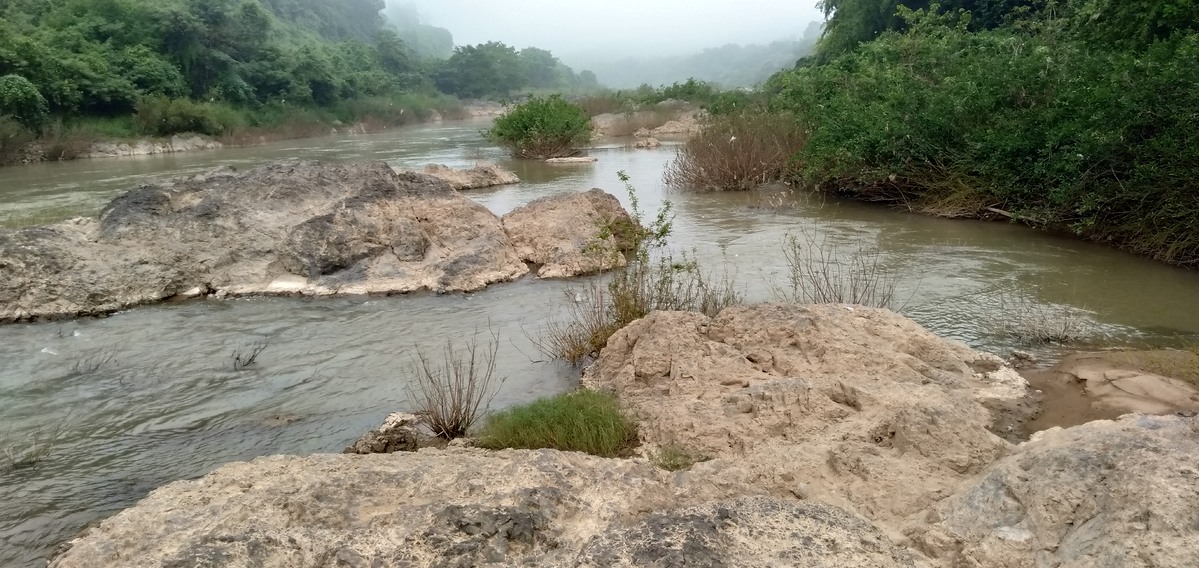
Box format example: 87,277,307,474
776,231,899,308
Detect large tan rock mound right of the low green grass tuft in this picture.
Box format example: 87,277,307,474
584,304,1028,522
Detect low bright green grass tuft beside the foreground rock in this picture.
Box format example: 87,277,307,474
476,389,637,458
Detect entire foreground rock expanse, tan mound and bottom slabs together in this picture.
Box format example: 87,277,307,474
50,304,1199,568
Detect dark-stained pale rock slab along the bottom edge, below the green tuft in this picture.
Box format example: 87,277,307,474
50,449,912,568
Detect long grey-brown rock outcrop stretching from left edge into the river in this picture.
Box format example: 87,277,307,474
0,162,628,322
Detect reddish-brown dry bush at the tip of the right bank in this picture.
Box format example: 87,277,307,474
664,109,808,192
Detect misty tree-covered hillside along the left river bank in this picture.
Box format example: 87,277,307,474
0,0,595,152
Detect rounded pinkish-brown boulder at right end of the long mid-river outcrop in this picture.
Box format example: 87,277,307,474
504,188,635,278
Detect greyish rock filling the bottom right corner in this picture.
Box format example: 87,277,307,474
910,413,1199,568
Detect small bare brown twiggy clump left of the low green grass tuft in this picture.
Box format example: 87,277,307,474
409,334,506,440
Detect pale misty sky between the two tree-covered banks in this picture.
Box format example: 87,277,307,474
387,0,823,61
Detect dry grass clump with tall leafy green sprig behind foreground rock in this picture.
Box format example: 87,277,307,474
536,171,742,364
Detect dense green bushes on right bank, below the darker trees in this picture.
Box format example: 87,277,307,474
767,18,1199,265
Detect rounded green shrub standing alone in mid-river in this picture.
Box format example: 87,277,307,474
483,95,591,159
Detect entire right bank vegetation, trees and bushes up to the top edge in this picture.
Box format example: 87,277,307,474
670,0,1199,266
